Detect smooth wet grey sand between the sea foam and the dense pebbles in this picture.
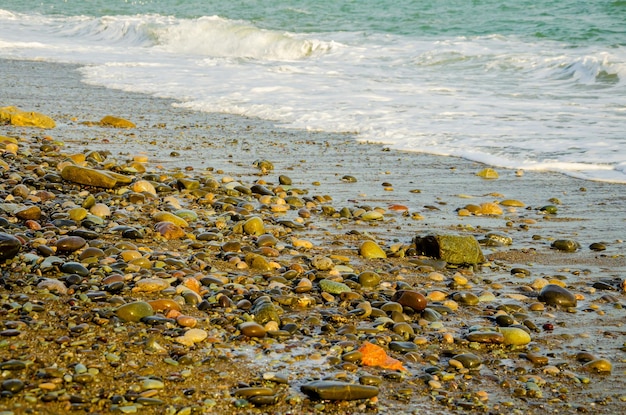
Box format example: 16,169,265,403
0,61,626,413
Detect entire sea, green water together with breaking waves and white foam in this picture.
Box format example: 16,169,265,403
0,0,626,183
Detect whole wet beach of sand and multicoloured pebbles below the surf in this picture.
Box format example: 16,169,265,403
0,60,626,415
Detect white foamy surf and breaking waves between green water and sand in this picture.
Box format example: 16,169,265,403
0,10,626,183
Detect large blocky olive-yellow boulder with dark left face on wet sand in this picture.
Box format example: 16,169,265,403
414,235,485,265
